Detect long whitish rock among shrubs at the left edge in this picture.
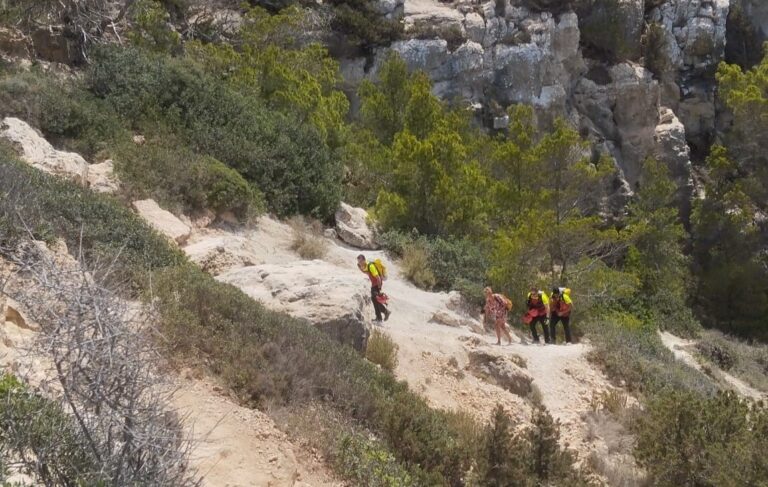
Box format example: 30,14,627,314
0,117,88,185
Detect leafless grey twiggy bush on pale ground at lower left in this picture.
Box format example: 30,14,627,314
0,241,199,486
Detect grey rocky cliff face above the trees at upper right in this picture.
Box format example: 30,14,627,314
342,0,768,215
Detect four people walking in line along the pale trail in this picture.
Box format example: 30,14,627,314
357,254,573,345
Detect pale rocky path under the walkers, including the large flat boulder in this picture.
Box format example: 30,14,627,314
185,218,611,462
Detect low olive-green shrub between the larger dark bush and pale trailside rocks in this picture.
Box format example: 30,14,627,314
115,136,264,218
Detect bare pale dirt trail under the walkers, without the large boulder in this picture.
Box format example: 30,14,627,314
185,218,611,462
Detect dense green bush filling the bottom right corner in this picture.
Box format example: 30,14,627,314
635,391,768,486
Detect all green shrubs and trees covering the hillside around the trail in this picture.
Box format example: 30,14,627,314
0,0,768,486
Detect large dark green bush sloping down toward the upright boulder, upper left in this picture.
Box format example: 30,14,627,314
88,48,341,218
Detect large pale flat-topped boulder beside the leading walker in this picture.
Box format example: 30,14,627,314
216,260,373,351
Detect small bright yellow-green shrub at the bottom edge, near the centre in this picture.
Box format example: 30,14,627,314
335,435,418,487
